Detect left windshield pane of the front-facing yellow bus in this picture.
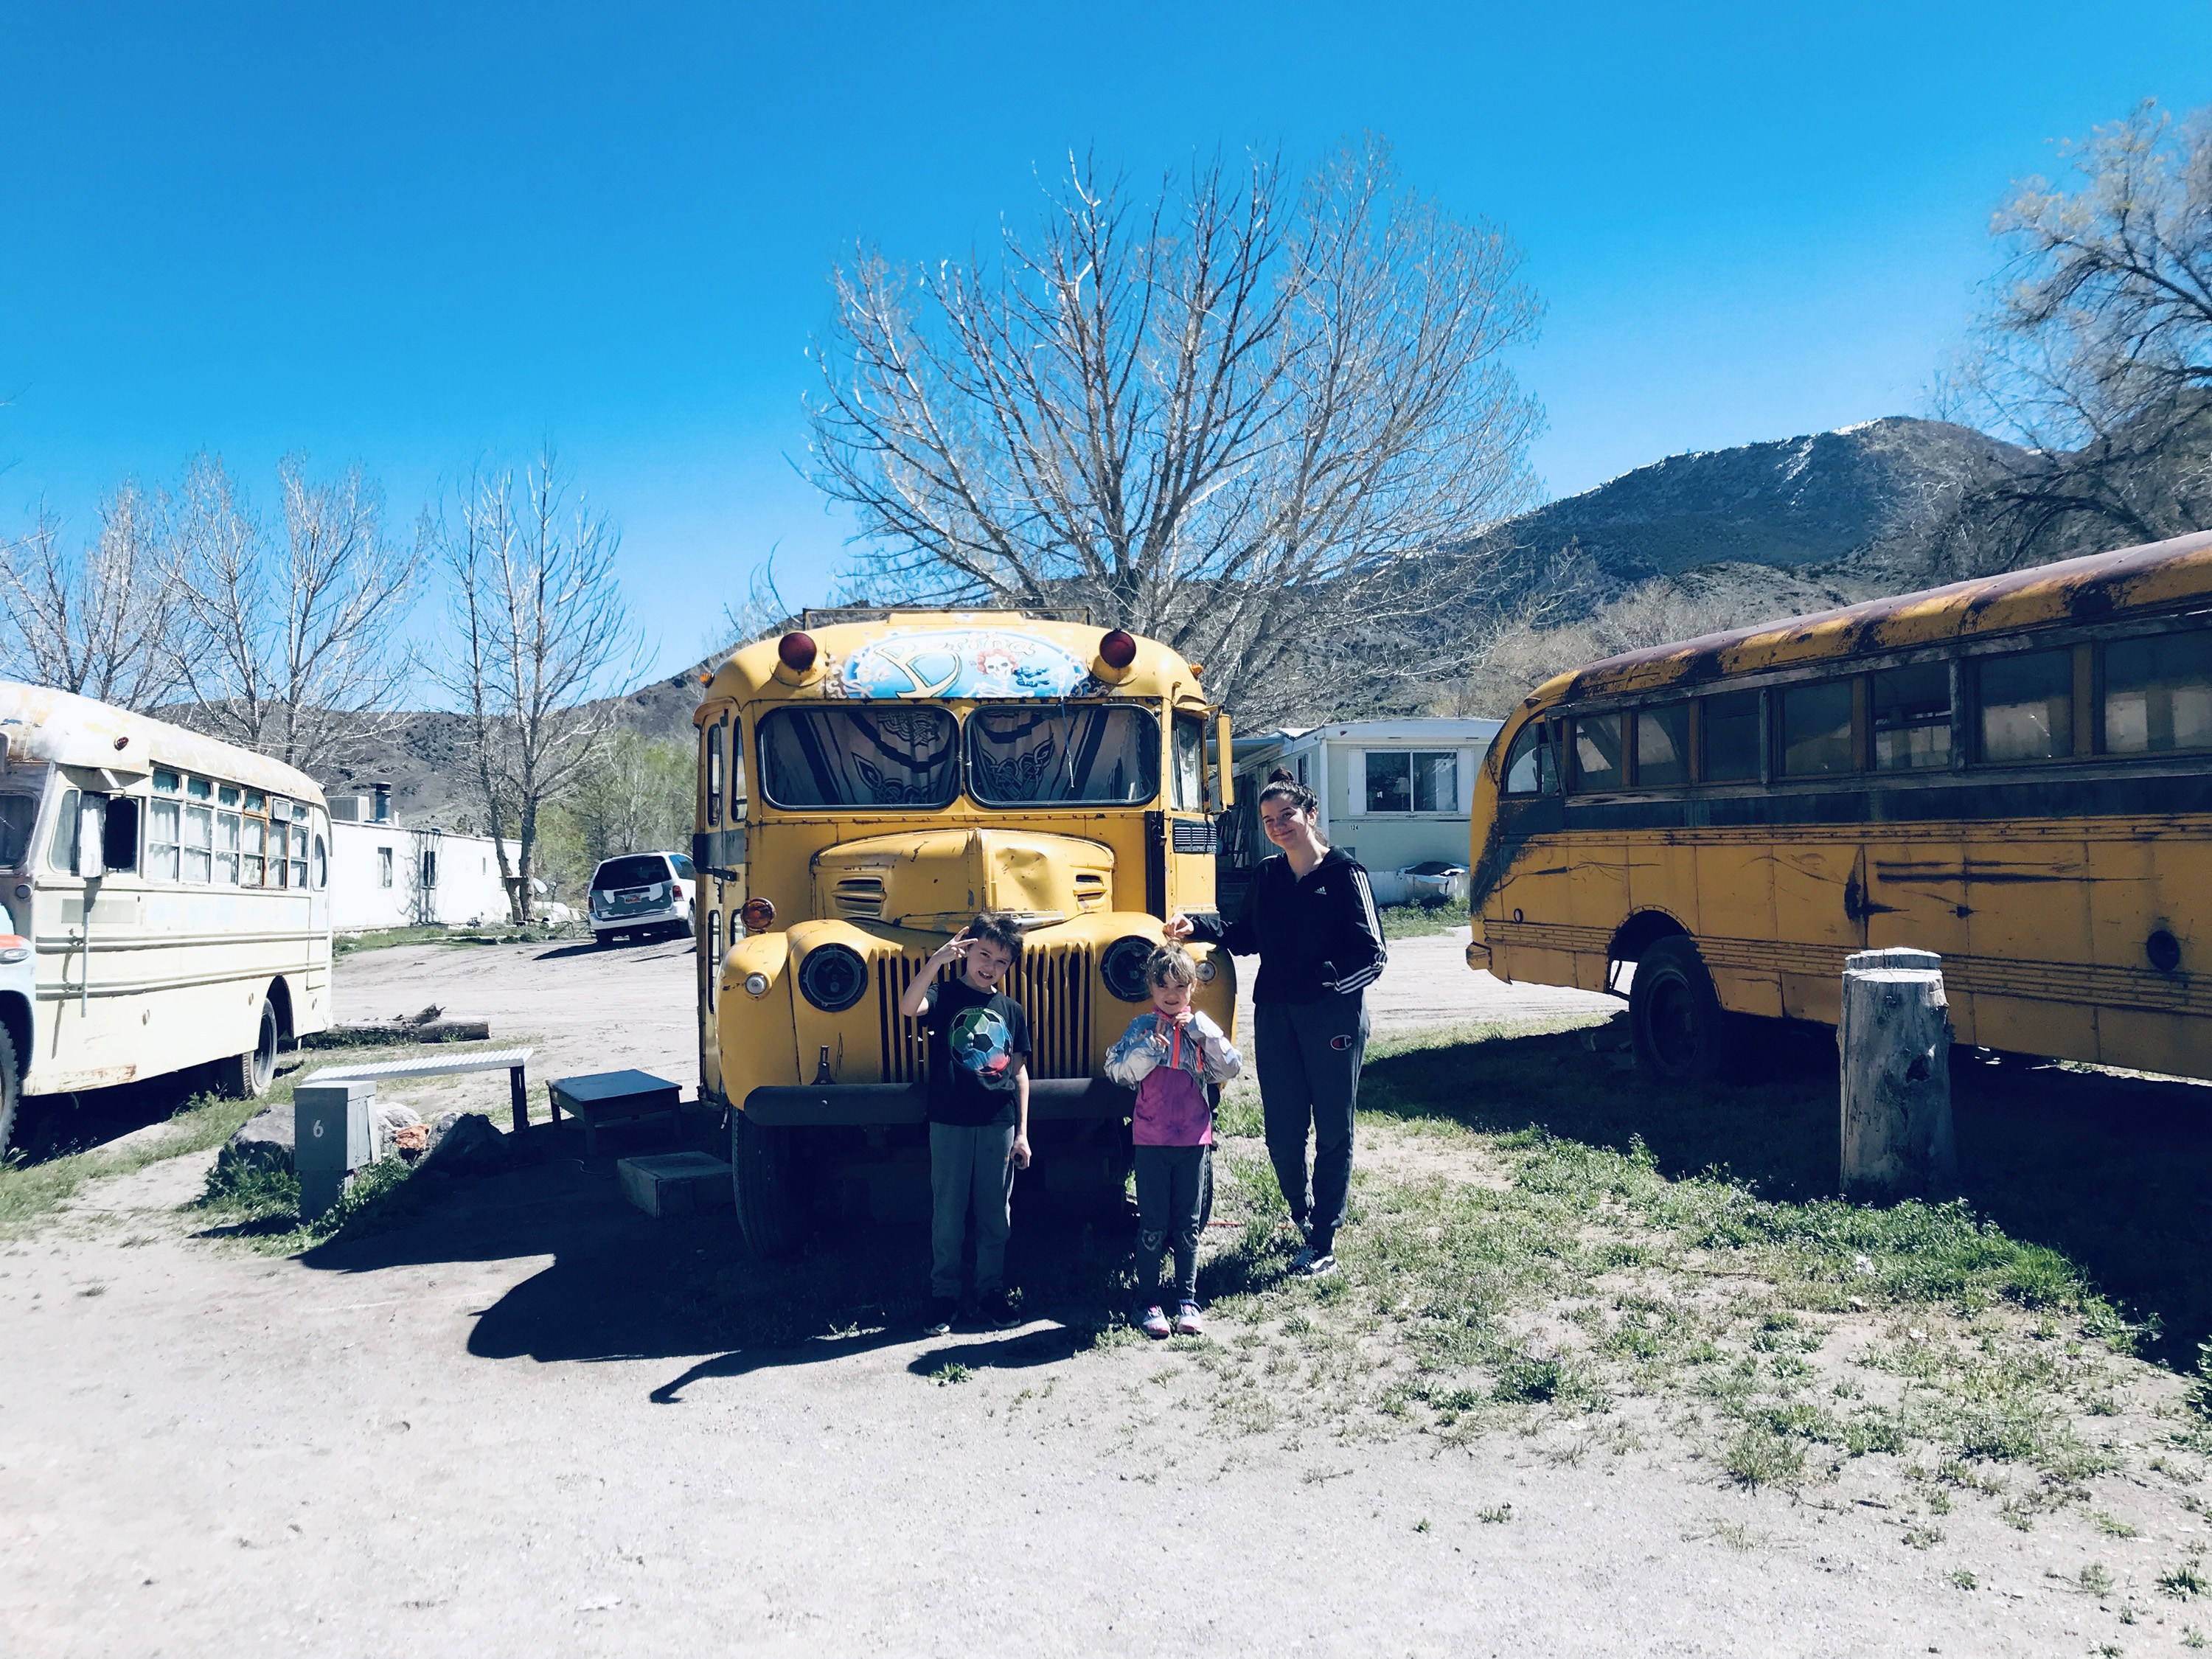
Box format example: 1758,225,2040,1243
761,706,960,807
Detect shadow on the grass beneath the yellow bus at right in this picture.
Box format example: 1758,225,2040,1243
1360,1018,2212,1371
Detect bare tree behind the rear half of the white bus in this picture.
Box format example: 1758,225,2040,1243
173,456,429,768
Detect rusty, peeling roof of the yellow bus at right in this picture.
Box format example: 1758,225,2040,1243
1522,531,2212,708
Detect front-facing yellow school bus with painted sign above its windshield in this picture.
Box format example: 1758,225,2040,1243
692,611,1237,1254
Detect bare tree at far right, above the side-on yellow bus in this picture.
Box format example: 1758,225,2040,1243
1942,100,2212,573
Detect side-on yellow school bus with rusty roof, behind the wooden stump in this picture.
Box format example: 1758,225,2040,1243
1469,535,2212,1079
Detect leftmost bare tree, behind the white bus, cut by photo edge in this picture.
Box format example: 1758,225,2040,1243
0,480,184,710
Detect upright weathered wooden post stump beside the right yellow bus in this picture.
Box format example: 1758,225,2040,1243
1836,949,1958,1203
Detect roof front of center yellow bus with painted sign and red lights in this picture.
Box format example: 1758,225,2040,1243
706,611,1206,703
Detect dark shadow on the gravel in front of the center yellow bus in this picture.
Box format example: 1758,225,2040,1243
283,1121,1126,1405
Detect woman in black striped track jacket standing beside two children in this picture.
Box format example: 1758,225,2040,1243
1166,772,1387,1276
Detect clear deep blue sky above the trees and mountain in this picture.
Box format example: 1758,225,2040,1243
0,0,2212,690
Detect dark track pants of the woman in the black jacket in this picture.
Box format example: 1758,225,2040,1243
1252,991,1367,1256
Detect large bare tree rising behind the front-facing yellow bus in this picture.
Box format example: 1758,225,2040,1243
810,137,1542,717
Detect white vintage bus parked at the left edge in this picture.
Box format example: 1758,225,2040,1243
0,679,330,1150
